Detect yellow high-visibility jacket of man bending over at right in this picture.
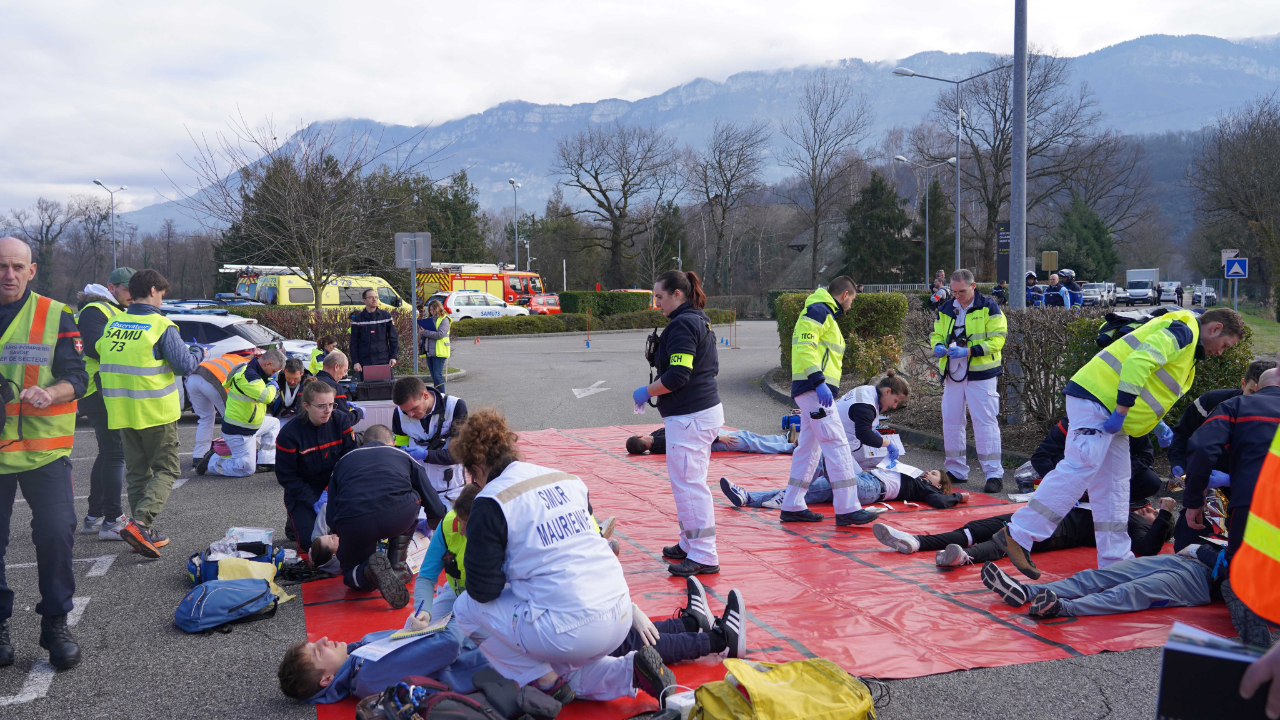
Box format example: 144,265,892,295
1071,310,1199,437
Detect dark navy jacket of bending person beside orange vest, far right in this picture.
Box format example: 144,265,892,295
1183,386,1280,510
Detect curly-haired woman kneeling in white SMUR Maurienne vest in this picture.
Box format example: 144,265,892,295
451,409,676,703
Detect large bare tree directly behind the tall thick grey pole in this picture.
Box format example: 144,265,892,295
914,53,1144,277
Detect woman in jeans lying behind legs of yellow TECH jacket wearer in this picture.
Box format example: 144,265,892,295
721,464,969,515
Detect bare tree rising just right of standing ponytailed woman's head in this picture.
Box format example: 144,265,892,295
686,120,769,293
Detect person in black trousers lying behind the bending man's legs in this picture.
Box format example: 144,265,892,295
872,497,1178,568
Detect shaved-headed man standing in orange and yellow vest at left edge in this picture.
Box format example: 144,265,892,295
0,237,88,669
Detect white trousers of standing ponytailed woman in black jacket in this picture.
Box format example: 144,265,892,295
663,405,724,565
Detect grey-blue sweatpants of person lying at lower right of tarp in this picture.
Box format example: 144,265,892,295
1028,555,1212,615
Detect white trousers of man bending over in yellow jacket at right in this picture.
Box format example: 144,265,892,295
1009,396,1133,568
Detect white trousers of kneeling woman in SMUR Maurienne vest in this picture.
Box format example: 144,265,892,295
455,586,634,701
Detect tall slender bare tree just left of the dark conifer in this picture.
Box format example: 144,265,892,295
778,69,874,287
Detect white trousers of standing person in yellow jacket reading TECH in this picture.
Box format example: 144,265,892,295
782,391,863,515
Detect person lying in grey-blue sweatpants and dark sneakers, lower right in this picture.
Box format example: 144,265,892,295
982,544,1226,618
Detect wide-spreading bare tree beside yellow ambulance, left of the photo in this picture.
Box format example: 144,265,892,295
172,118,430,311
